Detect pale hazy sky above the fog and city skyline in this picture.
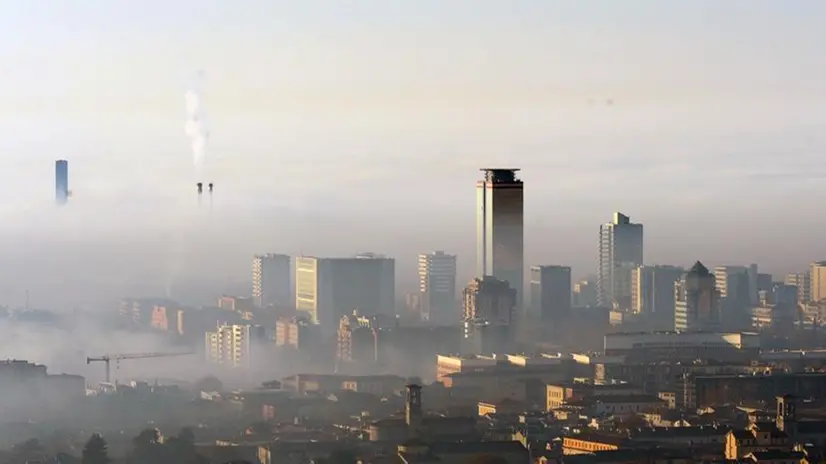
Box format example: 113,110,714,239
0,0,826,308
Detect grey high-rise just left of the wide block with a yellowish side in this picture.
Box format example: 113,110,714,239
252,253,292,308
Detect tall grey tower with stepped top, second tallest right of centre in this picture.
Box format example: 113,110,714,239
597,213,643,309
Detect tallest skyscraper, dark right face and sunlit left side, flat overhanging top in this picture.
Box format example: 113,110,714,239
476,169,525,308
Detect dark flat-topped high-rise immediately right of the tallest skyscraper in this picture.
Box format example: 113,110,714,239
530,266,571,322
